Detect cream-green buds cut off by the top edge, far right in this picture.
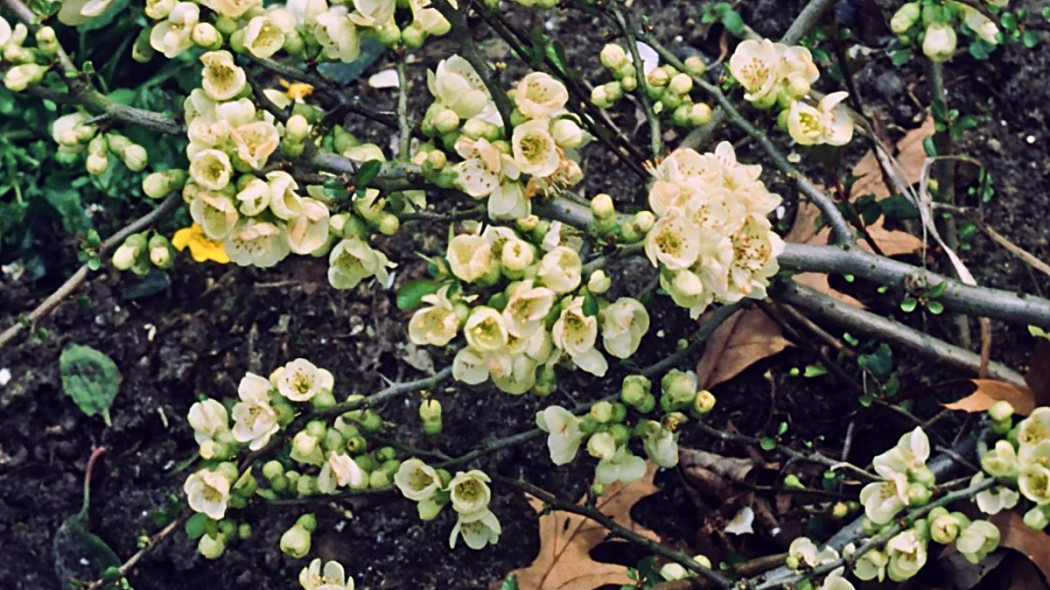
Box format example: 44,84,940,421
889,0,1009,62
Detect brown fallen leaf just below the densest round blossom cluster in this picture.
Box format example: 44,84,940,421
696,310,792,389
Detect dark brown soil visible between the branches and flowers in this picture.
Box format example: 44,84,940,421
0,0,1050,590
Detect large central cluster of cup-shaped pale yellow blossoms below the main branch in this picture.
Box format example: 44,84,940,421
408,222,649,395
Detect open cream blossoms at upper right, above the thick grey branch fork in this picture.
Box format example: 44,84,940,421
729,39,854,146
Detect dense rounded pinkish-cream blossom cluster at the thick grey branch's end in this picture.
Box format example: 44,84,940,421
645,142,783,317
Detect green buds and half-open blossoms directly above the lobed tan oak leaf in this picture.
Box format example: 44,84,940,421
536,370,715,482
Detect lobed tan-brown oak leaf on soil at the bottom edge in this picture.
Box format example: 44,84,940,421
510,463,659,590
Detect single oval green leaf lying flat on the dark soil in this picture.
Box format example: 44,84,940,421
59,344,122,426
